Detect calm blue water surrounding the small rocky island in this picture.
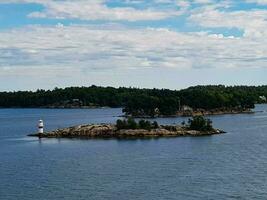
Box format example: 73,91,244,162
0,105,267,200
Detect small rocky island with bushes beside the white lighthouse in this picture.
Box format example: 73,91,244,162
28,116,225,138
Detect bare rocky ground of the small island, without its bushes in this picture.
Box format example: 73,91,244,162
28,124,225,138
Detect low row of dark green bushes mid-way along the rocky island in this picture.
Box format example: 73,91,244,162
116,118,159,130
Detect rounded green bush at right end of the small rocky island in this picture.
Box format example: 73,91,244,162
188,116,213,131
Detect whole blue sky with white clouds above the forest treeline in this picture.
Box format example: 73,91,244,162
0,0,267,91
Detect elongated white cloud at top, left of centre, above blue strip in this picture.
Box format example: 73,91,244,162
0,0,181,21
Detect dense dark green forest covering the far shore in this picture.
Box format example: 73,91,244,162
0,85,267,116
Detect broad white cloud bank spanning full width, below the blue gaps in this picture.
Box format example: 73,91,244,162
0,25,267,76
